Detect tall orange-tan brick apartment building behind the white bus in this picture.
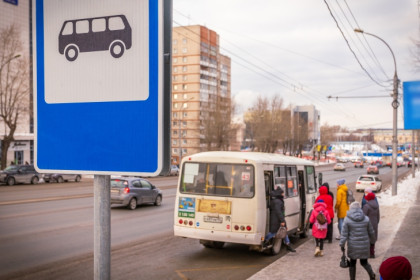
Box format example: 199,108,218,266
171,25,231,164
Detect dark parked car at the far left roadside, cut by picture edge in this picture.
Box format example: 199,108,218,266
0,165,39,186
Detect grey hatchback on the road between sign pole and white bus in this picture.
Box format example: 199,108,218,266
111,177,162,210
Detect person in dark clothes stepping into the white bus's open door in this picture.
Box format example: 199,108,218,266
265,187,296,252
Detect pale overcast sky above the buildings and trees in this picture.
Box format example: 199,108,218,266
173,0,420,129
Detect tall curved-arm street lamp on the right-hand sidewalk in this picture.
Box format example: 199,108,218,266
354,28,400,196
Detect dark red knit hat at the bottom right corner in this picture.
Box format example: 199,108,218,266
379,256,413,280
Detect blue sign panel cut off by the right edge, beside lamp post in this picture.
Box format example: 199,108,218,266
403,81,420,129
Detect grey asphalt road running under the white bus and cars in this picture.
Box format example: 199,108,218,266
0,164,409,279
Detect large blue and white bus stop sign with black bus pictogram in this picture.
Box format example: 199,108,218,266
33,0,171,176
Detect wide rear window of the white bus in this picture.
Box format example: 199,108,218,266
180,162,255,198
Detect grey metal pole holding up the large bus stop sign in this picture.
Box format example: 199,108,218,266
93,175,111,280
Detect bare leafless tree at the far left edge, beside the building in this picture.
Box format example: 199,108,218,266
0,25,29,169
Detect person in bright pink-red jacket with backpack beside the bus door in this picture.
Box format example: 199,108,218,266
309,199,331,257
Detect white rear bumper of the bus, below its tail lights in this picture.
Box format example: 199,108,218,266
174,226,264,245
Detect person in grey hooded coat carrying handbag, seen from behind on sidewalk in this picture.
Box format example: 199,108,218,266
340,201,376,280
